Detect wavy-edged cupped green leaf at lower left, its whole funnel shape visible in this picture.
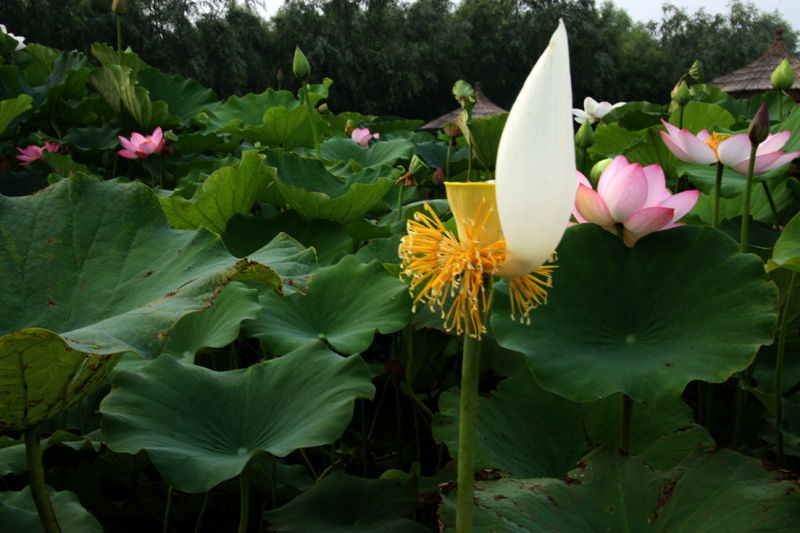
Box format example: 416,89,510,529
100,343,375,493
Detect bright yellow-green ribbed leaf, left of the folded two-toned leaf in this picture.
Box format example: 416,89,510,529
159,150,275,235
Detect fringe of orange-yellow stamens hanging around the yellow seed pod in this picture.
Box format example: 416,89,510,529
399,203,555,339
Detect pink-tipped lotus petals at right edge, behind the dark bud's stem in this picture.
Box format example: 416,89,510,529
718,130,800,176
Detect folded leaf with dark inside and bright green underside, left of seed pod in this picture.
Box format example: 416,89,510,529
266,147,394,227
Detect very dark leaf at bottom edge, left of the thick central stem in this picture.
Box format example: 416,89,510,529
264,471,430,533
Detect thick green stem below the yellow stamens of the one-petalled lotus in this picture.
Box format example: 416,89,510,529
456,333,481,533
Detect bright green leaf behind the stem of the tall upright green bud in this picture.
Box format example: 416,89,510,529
241,107,330,150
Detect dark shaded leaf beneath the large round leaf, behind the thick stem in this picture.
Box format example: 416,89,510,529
433,368,714,479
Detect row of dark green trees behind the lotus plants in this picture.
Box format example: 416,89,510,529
0,0,797,119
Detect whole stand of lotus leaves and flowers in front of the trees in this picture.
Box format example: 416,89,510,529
0,12,800,533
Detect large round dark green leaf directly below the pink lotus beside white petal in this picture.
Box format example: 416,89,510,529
492,224,777,404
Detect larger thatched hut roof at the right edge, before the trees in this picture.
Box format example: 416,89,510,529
708,28,800,102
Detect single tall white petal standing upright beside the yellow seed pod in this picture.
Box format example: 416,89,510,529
495,21,578,277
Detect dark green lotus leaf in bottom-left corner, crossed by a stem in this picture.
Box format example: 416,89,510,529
0,485,103,533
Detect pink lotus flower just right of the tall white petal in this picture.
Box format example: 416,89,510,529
572,156,700,246
